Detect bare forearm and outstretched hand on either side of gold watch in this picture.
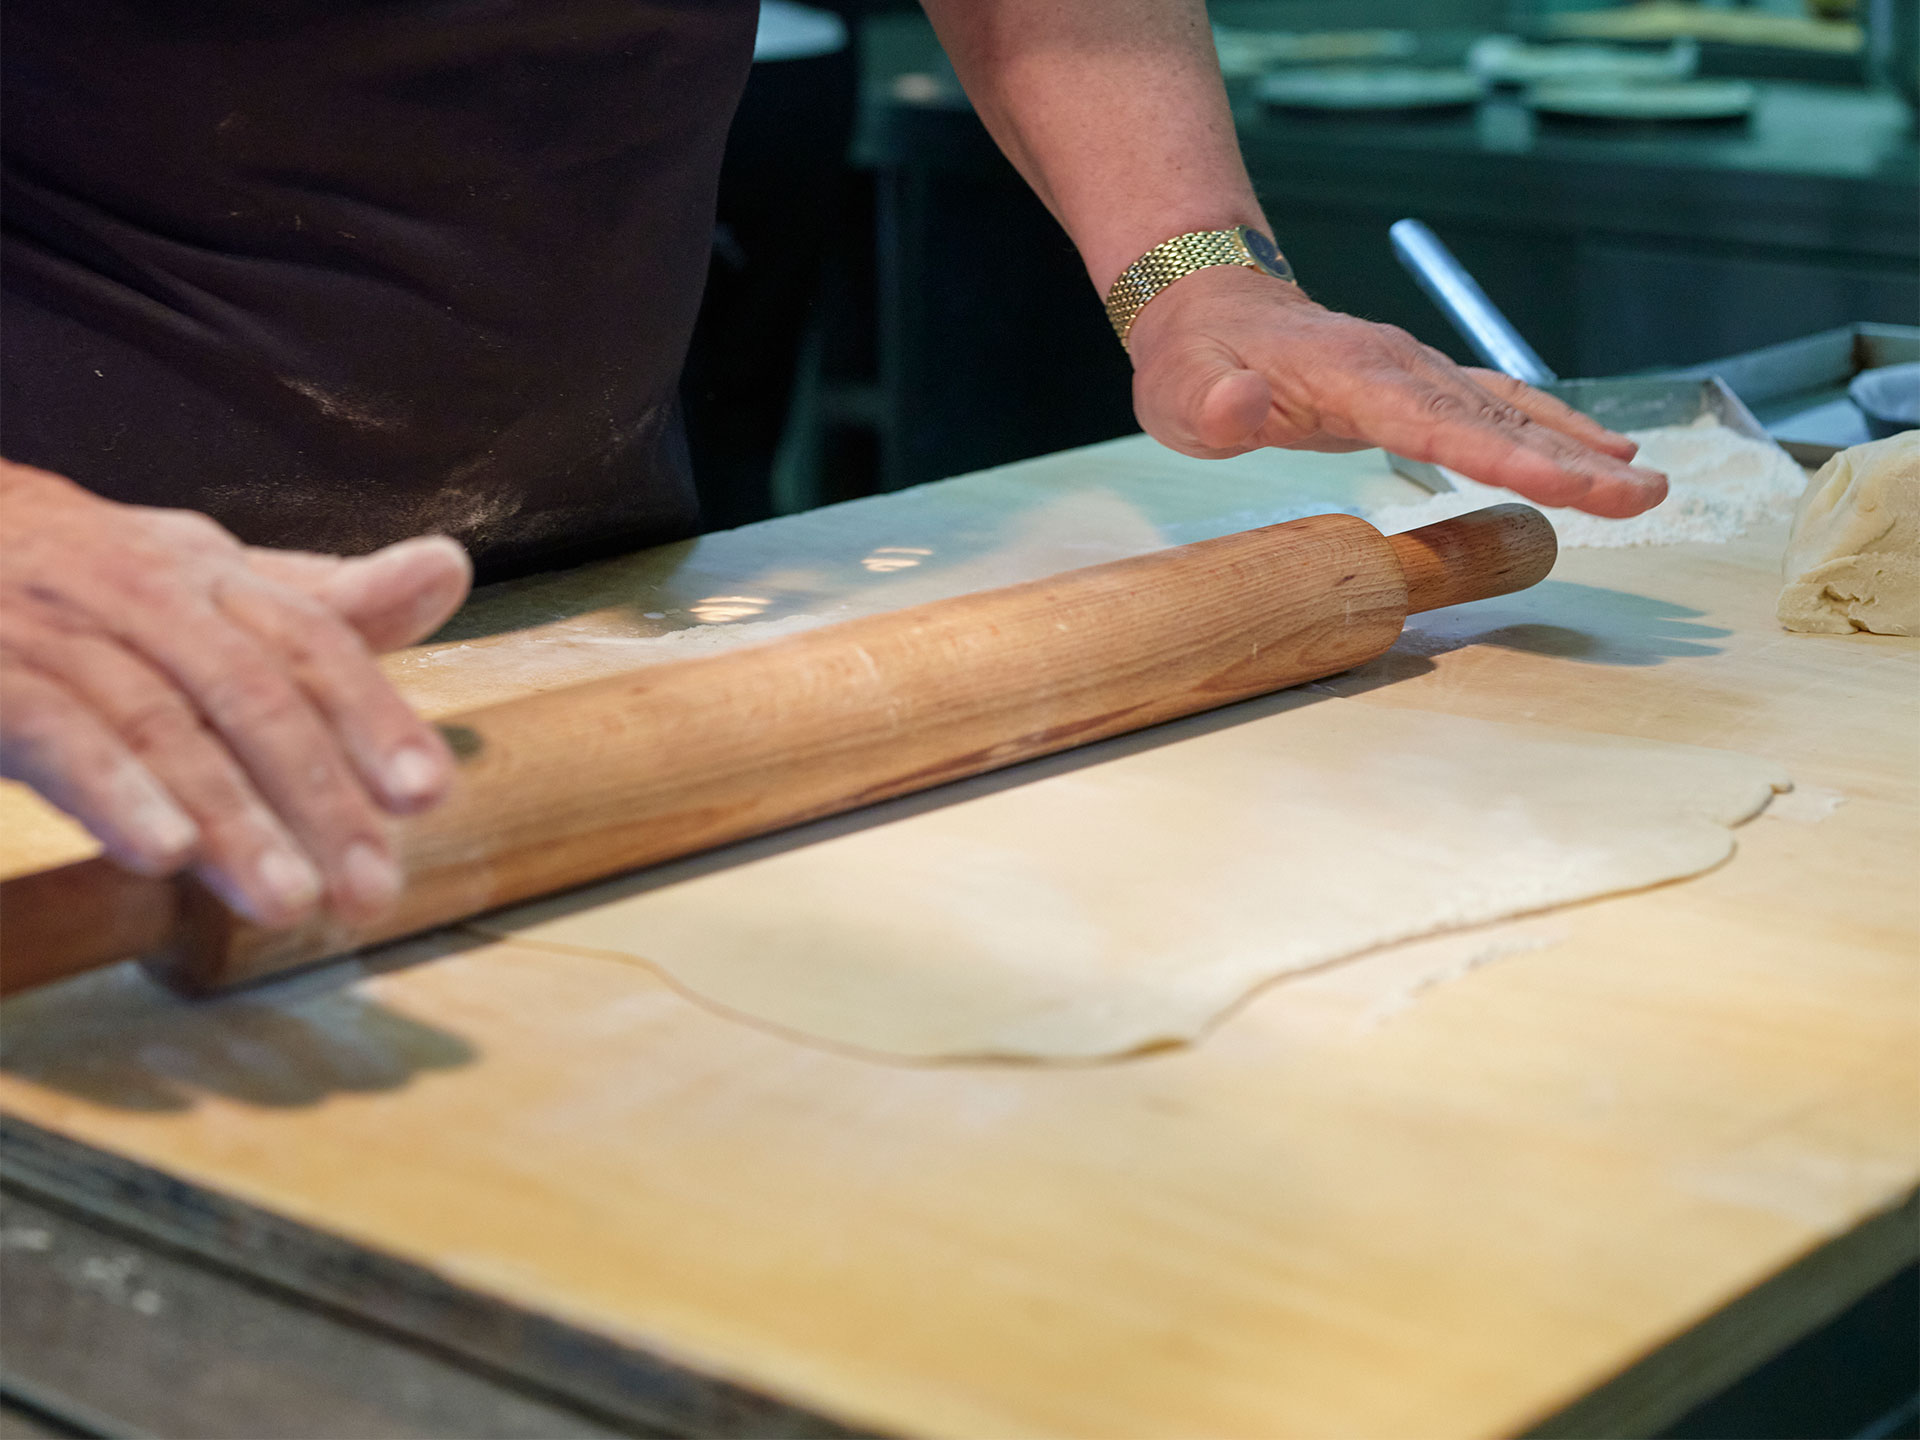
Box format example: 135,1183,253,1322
922,0,1667,516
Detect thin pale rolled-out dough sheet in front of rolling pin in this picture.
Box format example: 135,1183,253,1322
474,706,1789,1060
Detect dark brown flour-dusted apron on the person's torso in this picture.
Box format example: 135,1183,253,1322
0,0,756,576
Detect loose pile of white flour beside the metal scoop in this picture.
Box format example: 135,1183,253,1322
1367,415,1807,549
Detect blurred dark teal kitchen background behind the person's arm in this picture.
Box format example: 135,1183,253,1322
684,0,1920,528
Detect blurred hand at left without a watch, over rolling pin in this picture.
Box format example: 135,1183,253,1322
0,461,472,927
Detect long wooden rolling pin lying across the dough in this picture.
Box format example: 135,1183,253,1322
0,505,1555,993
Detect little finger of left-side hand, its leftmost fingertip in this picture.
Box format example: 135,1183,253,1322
0,664,200,876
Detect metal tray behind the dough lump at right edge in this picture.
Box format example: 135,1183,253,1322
1668,324,1920,467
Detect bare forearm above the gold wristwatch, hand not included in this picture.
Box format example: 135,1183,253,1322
924,0,1267,294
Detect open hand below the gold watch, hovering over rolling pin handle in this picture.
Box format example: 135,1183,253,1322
1129,265,1667,516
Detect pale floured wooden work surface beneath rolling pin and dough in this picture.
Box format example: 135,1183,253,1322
0,442,1920,1440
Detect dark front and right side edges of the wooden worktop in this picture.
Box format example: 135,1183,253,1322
0,1112,1920,1440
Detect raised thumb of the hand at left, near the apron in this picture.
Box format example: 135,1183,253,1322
248,536,472,653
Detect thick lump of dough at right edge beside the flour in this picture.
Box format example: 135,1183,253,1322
1778,430,1920,636
